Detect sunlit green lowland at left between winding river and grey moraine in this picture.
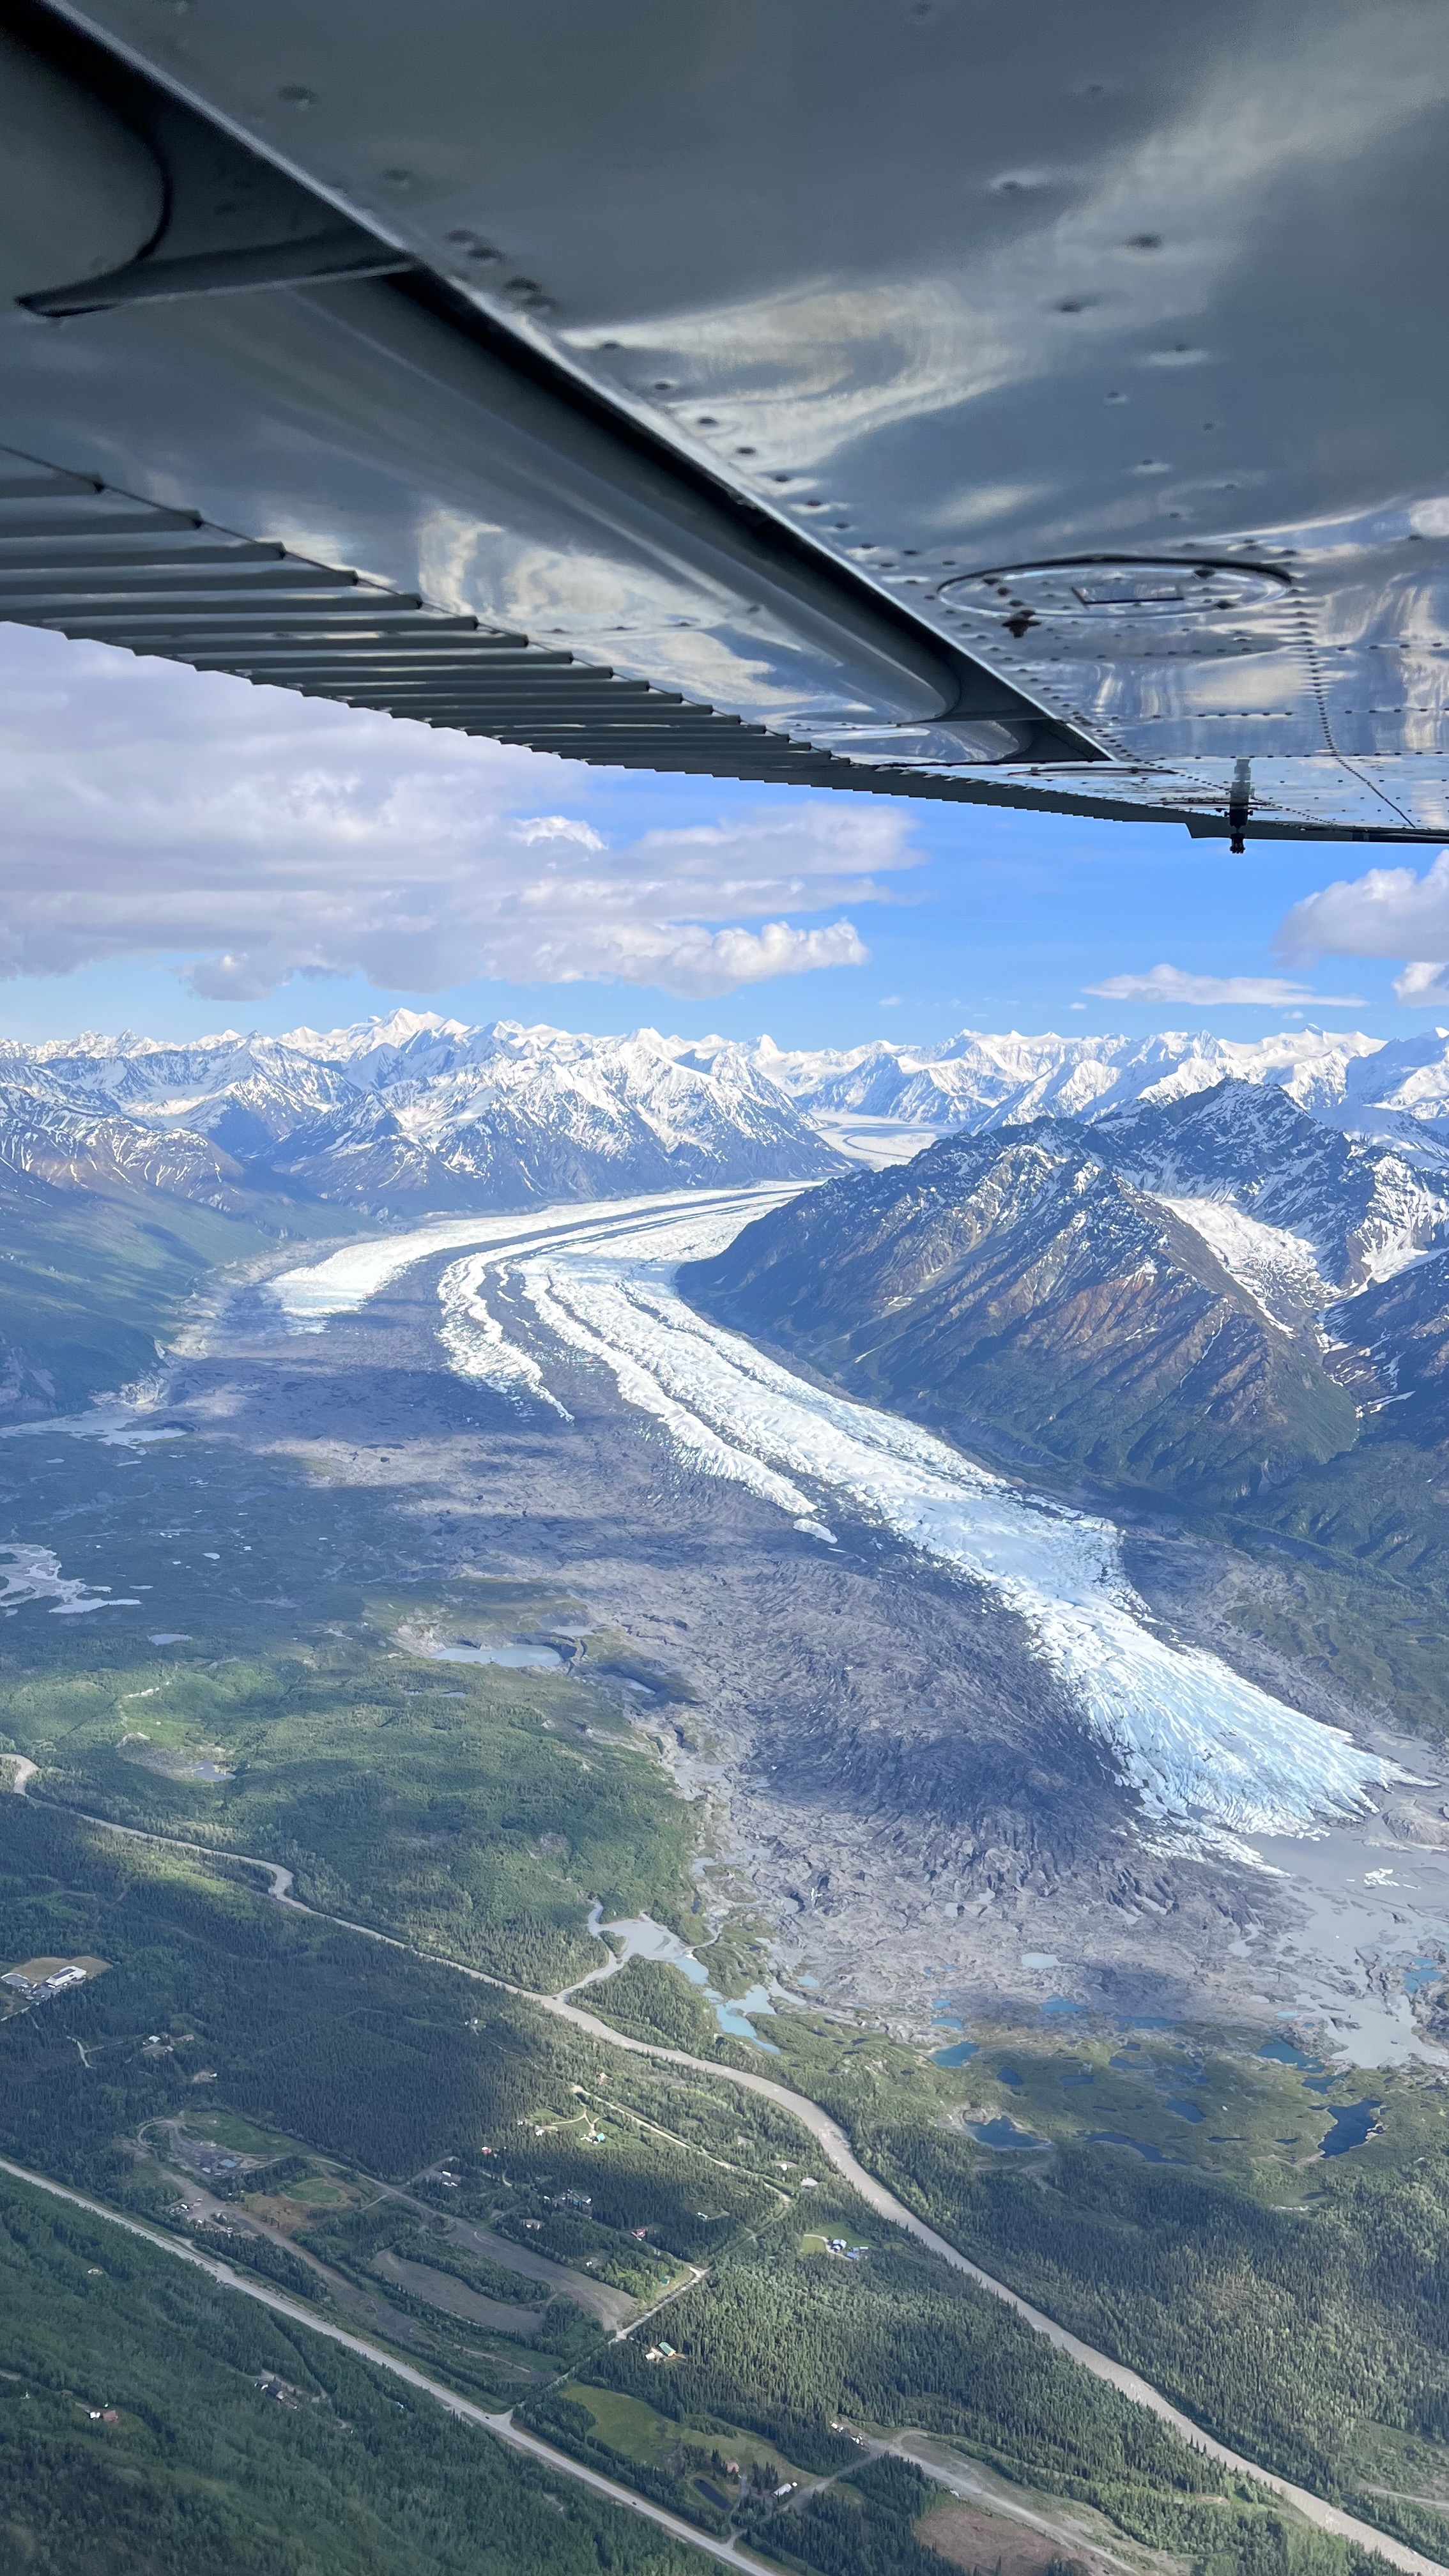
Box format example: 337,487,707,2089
0,1556,689,1991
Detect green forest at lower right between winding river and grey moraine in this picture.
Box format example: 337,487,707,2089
742,2017,1449,2556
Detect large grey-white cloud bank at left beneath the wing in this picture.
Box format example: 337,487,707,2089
0,629,923,1002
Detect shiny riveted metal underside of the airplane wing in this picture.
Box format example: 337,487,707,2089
0,0,1449,839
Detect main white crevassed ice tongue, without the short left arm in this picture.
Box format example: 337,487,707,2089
443,1206,1402,1860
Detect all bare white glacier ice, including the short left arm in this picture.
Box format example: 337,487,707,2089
271,1185,1407,1867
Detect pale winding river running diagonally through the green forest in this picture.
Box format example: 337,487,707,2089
17,1808,1449,2576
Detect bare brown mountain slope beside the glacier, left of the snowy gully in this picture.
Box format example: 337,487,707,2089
680,1118,1359,1499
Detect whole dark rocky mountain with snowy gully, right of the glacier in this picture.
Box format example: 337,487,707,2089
680,1082,1449,1502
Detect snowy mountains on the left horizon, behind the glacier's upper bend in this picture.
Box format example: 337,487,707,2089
0,1013,843,1221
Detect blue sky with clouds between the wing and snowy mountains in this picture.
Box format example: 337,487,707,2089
0,629,1449,1046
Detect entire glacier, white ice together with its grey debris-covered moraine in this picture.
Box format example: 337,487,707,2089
90,1190,1449,2064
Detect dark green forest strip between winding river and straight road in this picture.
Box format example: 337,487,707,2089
0,1803,1413,2576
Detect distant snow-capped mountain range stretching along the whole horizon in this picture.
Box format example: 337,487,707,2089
0,1010,1449,1226
